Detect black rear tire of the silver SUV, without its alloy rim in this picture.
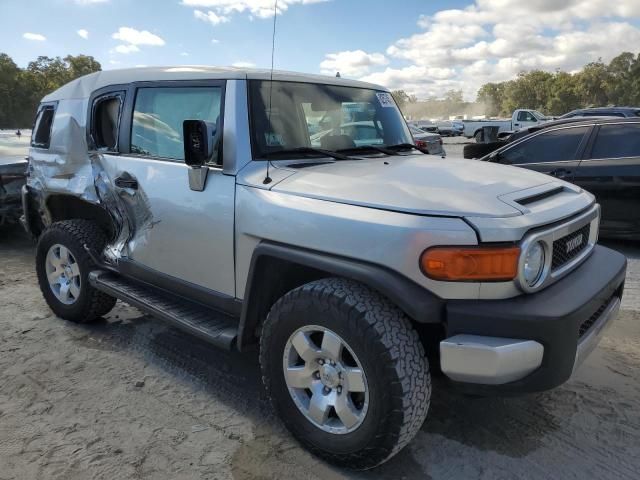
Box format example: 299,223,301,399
36,219,116,323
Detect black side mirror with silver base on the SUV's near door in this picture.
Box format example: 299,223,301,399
182,120,217,192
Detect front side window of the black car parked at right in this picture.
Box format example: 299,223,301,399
500,127,589,165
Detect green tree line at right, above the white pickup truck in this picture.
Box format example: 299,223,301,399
477,52,640,116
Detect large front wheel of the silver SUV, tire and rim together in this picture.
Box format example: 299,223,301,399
260,278,431,469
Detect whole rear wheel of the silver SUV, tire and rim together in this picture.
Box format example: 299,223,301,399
36,220,116,323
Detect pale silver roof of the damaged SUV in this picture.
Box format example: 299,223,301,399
43,65,388,102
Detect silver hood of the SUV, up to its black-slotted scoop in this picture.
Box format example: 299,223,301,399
272,155,556,217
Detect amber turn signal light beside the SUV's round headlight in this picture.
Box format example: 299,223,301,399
420,247,520,282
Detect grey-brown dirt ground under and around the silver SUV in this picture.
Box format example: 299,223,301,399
0,222,640,480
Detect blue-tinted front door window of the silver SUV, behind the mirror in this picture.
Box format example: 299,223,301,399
131,87,222,161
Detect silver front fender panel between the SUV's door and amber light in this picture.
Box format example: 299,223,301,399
235,185,480,298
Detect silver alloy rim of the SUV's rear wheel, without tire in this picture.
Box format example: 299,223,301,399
45,243,82,305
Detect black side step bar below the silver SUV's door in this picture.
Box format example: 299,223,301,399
89,270,238,350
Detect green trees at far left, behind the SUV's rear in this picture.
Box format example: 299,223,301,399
0,53,101,128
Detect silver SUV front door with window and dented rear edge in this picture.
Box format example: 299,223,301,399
91,82,235,296
